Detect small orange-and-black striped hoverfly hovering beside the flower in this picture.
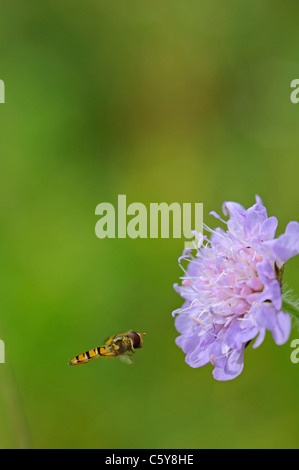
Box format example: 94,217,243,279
69,330,145,366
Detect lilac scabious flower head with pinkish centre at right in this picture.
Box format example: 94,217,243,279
173,196,299,380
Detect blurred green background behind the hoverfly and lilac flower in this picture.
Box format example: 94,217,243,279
0,0,299,449
